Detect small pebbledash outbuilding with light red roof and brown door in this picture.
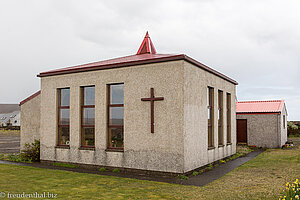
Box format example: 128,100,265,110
236,100,287,148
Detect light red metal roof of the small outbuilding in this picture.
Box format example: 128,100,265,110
236,100,284,114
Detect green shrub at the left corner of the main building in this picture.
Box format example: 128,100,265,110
20,140,40,162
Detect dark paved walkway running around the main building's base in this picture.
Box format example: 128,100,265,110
0,150,263,186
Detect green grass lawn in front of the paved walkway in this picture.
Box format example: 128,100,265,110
0,148,300,199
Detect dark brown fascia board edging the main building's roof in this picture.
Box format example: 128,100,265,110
37,54,238,85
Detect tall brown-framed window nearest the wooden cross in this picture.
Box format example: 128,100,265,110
108,84,124,150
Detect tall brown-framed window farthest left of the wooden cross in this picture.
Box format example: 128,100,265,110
57,88,70,146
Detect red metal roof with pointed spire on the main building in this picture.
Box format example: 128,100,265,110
38,32,238,85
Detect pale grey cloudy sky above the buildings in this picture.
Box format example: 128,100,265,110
0,0,300,120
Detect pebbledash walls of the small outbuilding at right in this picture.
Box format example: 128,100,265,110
237,106,287,148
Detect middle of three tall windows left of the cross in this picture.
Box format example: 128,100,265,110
81,86,95,147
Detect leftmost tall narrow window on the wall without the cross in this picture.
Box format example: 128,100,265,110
207,87,214,147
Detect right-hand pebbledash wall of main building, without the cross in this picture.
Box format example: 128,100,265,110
183,62,236,172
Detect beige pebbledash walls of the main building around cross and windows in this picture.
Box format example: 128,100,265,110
22,60,236,173
